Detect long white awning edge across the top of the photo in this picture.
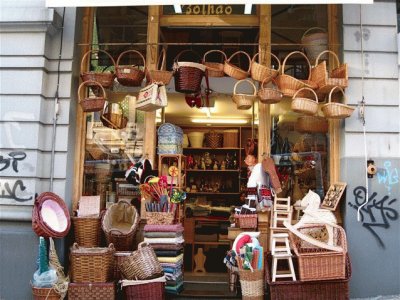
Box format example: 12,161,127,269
46,0,374,7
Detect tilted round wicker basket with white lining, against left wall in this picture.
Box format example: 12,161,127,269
32,192,71,238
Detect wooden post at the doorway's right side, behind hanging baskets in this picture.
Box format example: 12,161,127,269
258,5,271,161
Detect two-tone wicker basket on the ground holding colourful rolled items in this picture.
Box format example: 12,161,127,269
239,269,265,300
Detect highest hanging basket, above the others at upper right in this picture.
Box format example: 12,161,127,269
301,27,328,63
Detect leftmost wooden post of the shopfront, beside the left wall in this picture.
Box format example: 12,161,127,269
72,7,94,211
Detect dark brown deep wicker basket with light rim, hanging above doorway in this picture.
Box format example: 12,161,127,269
174,50,206,94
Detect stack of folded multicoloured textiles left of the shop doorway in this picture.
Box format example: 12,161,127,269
144,224,184,294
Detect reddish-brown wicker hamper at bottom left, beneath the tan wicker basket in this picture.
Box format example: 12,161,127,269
68,282,115,300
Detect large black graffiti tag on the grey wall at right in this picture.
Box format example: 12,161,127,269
348,186,399,248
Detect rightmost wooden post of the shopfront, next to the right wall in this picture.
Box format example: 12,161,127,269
328,4,340,184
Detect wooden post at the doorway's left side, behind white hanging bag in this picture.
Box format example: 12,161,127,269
144,6,160,164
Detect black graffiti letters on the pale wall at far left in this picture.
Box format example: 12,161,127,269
0,151,33,202
